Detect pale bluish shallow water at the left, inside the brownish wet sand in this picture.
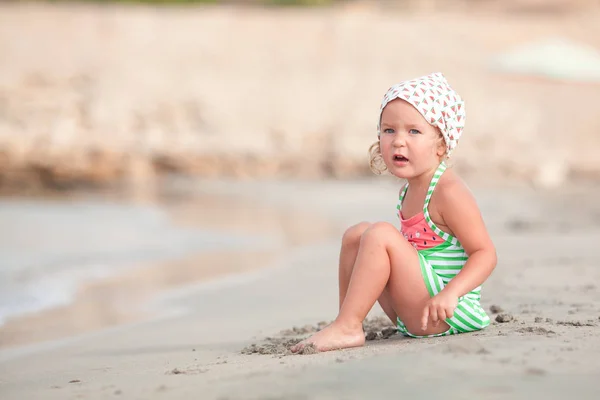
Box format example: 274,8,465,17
0,199,276,325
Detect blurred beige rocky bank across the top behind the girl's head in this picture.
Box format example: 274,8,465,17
0,0,600,193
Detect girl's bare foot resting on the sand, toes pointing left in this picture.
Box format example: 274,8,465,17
290,321,365,353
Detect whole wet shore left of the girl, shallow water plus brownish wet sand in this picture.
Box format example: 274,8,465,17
0,178,337,350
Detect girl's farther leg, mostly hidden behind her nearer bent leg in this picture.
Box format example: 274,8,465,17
338,222,396,325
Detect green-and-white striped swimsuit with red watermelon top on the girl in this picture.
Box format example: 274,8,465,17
397,162,490,338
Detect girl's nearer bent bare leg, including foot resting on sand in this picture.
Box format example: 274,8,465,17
292,223,449,351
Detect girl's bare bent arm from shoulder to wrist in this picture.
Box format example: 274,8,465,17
438,179,497,297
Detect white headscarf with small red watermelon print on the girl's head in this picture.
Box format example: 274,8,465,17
377,72,466,157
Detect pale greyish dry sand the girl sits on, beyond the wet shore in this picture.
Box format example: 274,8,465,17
0,179,600,399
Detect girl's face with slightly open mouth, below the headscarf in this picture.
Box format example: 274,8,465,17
379,99,446,179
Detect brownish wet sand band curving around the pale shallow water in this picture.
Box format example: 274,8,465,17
0,188,340,349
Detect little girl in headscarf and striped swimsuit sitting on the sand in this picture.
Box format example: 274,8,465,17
292,73,496,352
